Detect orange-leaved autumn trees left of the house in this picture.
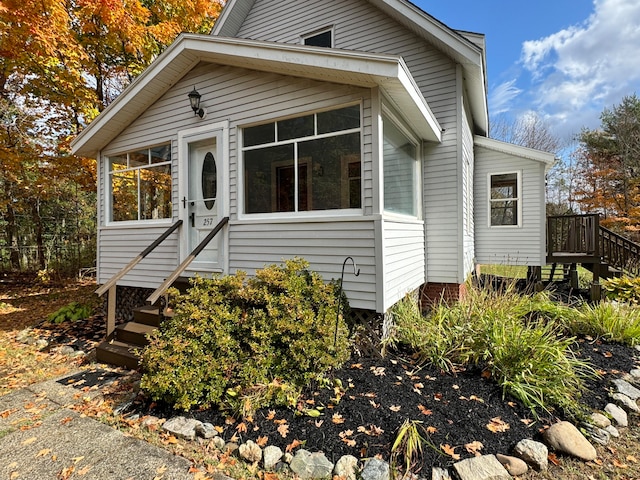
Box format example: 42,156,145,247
0,0,222,269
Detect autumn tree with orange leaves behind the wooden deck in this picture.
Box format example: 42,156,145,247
575,94,640,240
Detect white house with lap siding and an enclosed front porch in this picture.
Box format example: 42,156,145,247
73,0,553,322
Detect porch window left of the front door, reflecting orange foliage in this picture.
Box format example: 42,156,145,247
107,144,171,222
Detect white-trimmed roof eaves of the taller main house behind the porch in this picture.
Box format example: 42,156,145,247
211,0,489,133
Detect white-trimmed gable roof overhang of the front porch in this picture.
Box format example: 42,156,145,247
71,34,442,156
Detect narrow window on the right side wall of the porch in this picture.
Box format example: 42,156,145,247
382,116,419,217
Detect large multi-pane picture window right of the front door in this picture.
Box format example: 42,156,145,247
243,105,362,213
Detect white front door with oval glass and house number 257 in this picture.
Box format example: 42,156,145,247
181,125,226,273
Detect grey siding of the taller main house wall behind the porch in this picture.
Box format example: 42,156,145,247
238,0,460,282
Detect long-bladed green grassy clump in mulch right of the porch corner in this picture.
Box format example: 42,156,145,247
389,286,595,415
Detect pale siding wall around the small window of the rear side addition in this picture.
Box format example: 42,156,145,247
475,146,545,266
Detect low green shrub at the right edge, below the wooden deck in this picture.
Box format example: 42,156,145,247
567,302,640,346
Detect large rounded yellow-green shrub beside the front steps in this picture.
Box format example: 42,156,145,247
142,259,349,414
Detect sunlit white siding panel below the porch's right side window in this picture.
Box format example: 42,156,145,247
382,220,425,310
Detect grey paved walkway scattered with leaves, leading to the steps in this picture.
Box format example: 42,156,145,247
0,375,193,480
